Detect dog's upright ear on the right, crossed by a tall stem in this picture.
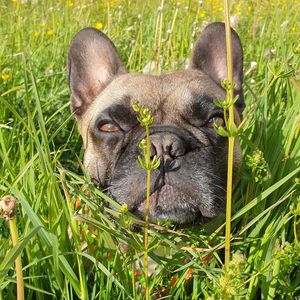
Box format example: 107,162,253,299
189,22,244,111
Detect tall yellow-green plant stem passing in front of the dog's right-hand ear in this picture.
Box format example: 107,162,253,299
224,0,234,267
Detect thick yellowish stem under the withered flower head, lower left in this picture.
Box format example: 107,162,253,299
8,218,25,300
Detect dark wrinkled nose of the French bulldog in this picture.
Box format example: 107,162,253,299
150,134,186,162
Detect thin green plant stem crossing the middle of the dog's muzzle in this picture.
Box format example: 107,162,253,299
144,125,151,300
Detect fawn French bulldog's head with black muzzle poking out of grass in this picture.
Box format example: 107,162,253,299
69,23,243,223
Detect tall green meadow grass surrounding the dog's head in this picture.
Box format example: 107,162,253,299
0,0,300,299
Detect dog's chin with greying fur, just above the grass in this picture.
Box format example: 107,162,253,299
134,184,215,224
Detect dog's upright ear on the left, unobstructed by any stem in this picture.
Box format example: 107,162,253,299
68,28,126,117
